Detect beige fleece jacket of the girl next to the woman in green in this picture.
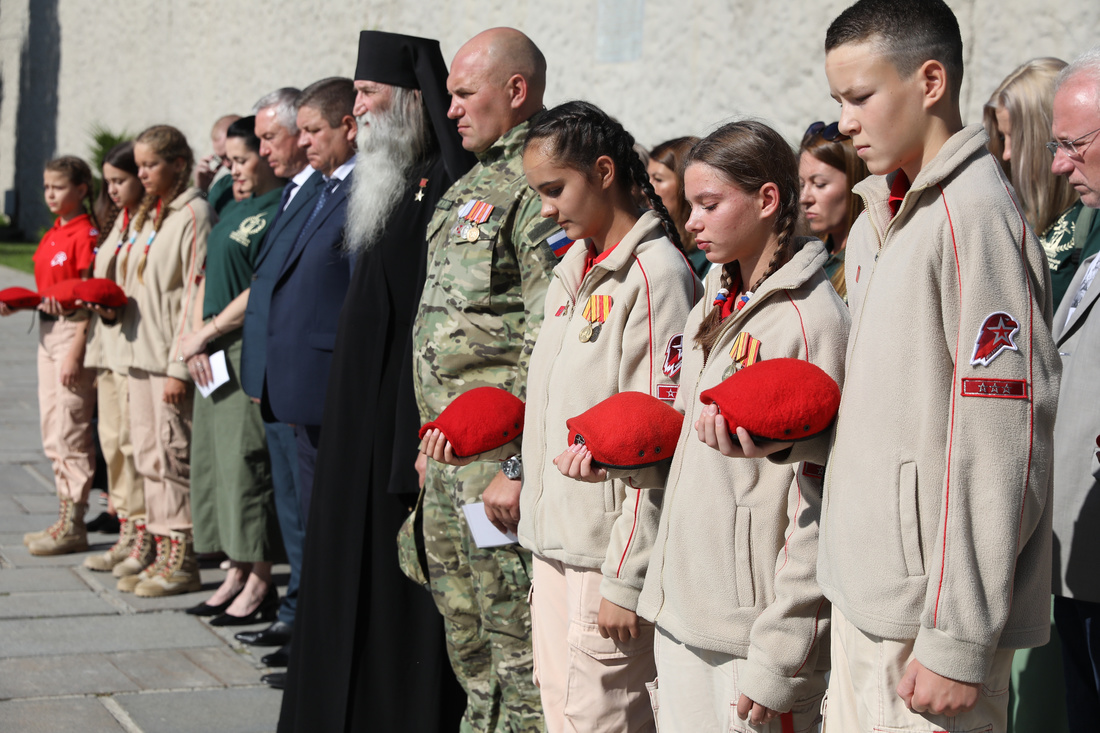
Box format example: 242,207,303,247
118,187,218,382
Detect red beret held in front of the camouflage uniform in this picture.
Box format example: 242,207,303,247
420,387,524,458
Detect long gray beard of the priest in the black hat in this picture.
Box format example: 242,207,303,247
344,105,424,254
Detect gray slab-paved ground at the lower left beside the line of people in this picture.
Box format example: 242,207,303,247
0,266,288,733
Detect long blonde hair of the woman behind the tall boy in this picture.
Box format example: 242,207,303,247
982,57,1077,234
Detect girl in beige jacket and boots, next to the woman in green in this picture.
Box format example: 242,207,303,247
118,124,217,597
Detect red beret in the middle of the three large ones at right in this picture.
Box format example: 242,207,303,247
565,392,684,469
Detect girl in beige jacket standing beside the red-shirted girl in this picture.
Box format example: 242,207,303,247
84,141,149,577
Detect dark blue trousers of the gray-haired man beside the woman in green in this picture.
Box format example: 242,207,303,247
264,423,306,626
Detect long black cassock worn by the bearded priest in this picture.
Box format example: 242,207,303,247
278,150,465,733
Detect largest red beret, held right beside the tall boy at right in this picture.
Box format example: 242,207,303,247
699,359,840,441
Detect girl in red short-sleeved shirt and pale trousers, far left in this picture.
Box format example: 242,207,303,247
0,155,99,555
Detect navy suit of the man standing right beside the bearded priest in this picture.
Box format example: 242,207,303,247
263,171,354,524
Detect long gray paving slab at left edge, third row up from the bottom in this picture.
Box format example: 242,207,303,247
0,613,217,658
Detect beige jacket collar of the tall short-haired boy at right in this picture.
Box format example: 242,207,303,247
851,124,990,236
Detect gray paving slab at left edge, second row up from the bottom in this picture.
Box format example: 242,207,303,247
0,654,141,695
